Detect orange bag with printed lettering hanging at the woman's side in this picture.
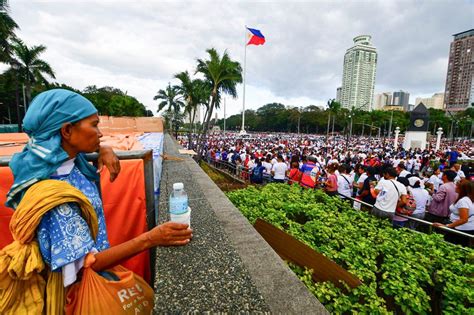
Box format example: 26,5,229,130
65,254,154,315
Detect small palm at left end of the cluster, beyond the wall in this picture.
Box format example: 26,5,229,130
153,83,184,134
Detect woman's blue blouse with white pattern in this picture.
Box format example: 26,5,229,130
38,166,110,271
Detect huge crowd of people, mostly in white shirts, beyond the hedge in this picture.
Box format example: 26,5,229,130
179,133,474,246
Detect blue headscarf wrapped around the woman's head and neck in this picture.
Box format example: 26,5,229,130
6,89,99,209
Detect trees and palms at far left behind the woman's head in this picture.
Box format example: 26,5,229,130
0,0,153,130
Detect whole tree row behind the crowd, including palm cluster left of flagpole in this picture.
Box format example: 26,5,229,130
161,53,474,141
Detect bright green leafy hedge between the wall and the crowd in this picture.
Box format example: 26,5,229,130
227,184,474,314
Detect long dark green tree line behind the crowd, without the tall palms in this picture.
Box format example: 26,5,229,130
216,99,474,137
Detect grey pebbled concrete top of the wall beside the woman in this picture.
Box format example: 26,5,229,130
154,134,328,314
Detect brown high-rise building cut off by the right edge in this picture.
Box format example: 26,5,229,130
444,29,474,111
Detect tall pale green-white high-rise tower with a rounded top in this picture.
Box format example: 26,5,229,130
341,35,377,110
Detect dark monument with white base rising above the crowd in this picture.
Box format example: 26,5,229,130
403,103,430,150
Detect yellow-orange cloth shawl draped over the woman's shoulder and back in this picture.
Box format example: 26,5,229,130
0,179,98,315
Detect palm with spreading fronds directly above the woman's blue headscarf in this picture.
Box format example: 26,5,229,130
10,39,56,104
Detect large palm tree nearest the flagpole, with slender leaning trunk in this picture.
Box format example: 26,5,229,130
196,48,242,158
